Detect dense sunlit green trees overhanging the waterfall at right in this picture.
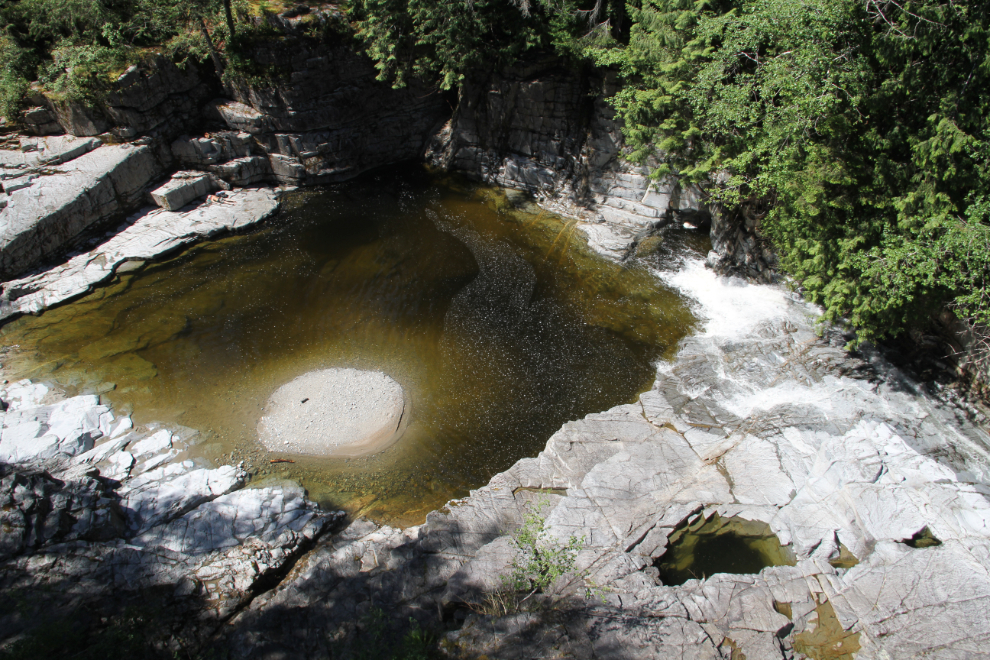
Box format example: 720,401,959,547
591,0,990,346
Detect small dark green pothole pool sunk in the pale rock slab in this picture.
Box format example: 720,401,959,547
654,513,796,586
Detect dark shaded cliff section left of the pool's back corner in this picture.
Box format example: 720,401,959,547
215,39,450,185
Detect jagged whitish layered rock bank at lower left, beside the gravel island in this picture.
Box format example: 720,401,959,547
0,381,339,638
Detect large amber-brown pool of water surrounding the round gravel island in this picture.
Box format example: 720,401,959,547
2,168,704,524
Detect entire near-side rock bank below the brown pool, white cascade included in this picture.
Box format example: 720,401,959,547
0,254,990,658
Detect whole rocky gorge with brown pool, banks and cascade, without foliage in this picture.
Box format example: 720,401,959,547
0,9,990,660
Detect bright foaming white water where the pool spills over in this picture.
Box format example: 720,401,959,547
656,259,820,339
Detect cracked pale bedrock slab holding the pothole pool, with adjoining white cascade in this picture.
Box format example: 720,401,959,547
215,263,990,659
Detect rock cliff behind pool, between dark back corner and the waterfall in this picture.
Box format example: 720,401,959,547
427,58,708,258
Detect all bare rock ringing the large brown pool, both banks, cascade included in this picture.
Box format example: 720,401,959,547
0,16,990,660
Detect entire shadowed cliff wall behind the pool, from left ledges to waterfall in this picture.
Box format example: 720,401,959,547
3,27,775,280
